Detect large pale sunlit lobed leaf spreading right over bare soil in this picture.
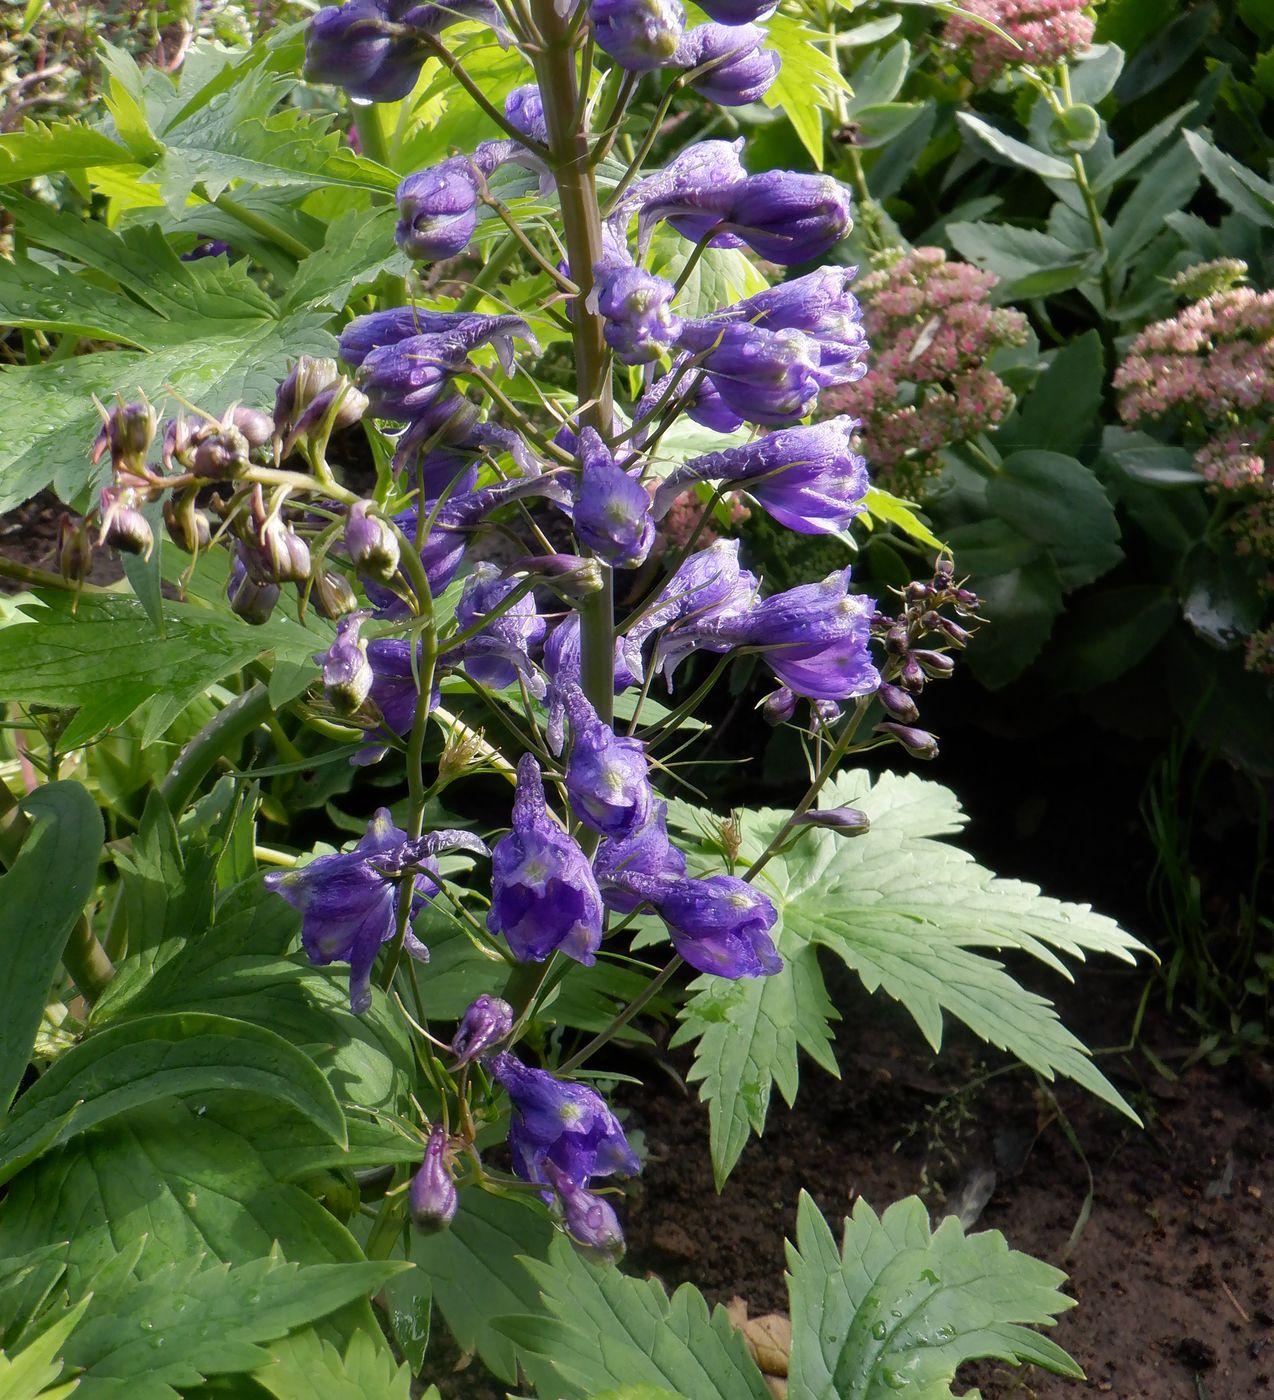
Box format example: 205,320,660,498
668,771,1141,1180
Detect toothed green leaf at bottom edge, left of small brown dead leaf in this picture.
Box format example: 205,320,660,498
501,1236,770,1400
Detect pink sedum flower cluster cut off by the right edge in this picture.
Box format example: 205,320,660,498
1114,287,1274,673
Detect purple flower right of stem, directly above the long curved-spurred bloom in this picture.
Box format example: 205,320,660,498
680,321,819,423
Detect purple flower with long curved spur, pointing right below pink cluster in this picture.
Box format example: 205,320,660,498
655,417,868,535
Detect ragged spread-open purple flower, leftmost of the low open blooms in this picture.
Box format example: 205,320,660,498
265,808,487,1015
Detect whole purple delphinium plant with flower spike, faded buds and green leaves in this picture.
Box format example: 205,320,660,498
0,0,1153,1400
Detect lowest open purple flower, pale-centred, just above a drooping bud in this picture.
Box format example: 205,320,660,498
490,1051,641,1189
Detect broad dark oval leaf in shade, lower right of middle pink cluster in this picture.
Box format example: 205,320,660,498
987,451,1124,588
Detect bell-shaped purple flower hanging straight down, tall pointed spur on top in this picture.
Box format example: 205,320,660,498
487,753,602,966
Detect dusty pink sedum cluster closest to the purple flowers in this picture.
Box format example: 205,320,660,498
822,248,1026,497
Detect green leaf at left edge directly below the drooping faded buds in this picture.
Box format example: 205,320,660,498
0,593,325,748
